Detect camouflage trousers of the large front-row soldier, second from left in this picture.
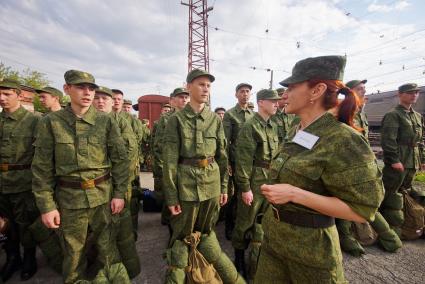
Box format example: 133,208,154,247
58,202,119,283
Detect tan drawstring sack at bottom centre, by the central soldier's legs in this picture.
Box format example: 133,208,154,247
184,232,223,284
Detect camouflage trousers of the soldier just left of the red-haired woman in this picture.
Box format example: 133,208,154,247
232,192,269,249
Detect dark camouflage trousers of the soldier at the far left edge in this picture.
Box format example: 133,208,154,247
0,190,40,250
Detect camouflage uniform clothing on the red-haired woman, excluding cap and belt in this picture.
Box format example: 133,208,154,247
256,113,384,283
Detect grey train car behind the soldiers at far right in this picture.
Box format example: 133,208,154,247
365,86,425,131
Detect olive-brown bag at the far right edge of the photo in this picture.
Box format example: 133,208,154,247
401,190,425,240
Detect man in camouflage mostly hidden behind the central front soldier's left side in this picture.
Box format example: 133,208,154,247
153,88,189,235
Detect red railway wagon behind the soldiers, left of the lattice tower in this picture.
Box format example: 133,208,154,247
137,95,170,129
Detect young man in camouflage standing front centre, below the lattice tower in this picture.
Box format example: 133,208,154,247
163,69,243,283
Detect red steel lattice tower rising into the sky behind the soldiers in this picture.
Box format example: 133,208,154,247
181,0,213,72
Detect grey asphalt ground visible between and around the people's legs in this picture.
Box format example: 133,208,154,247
0,173,425,284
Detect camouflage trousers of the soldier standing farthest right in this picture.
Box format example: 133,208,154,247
379,164,416,233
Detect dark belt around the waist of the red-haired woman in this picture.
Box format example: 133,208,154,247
272,206,335,229
